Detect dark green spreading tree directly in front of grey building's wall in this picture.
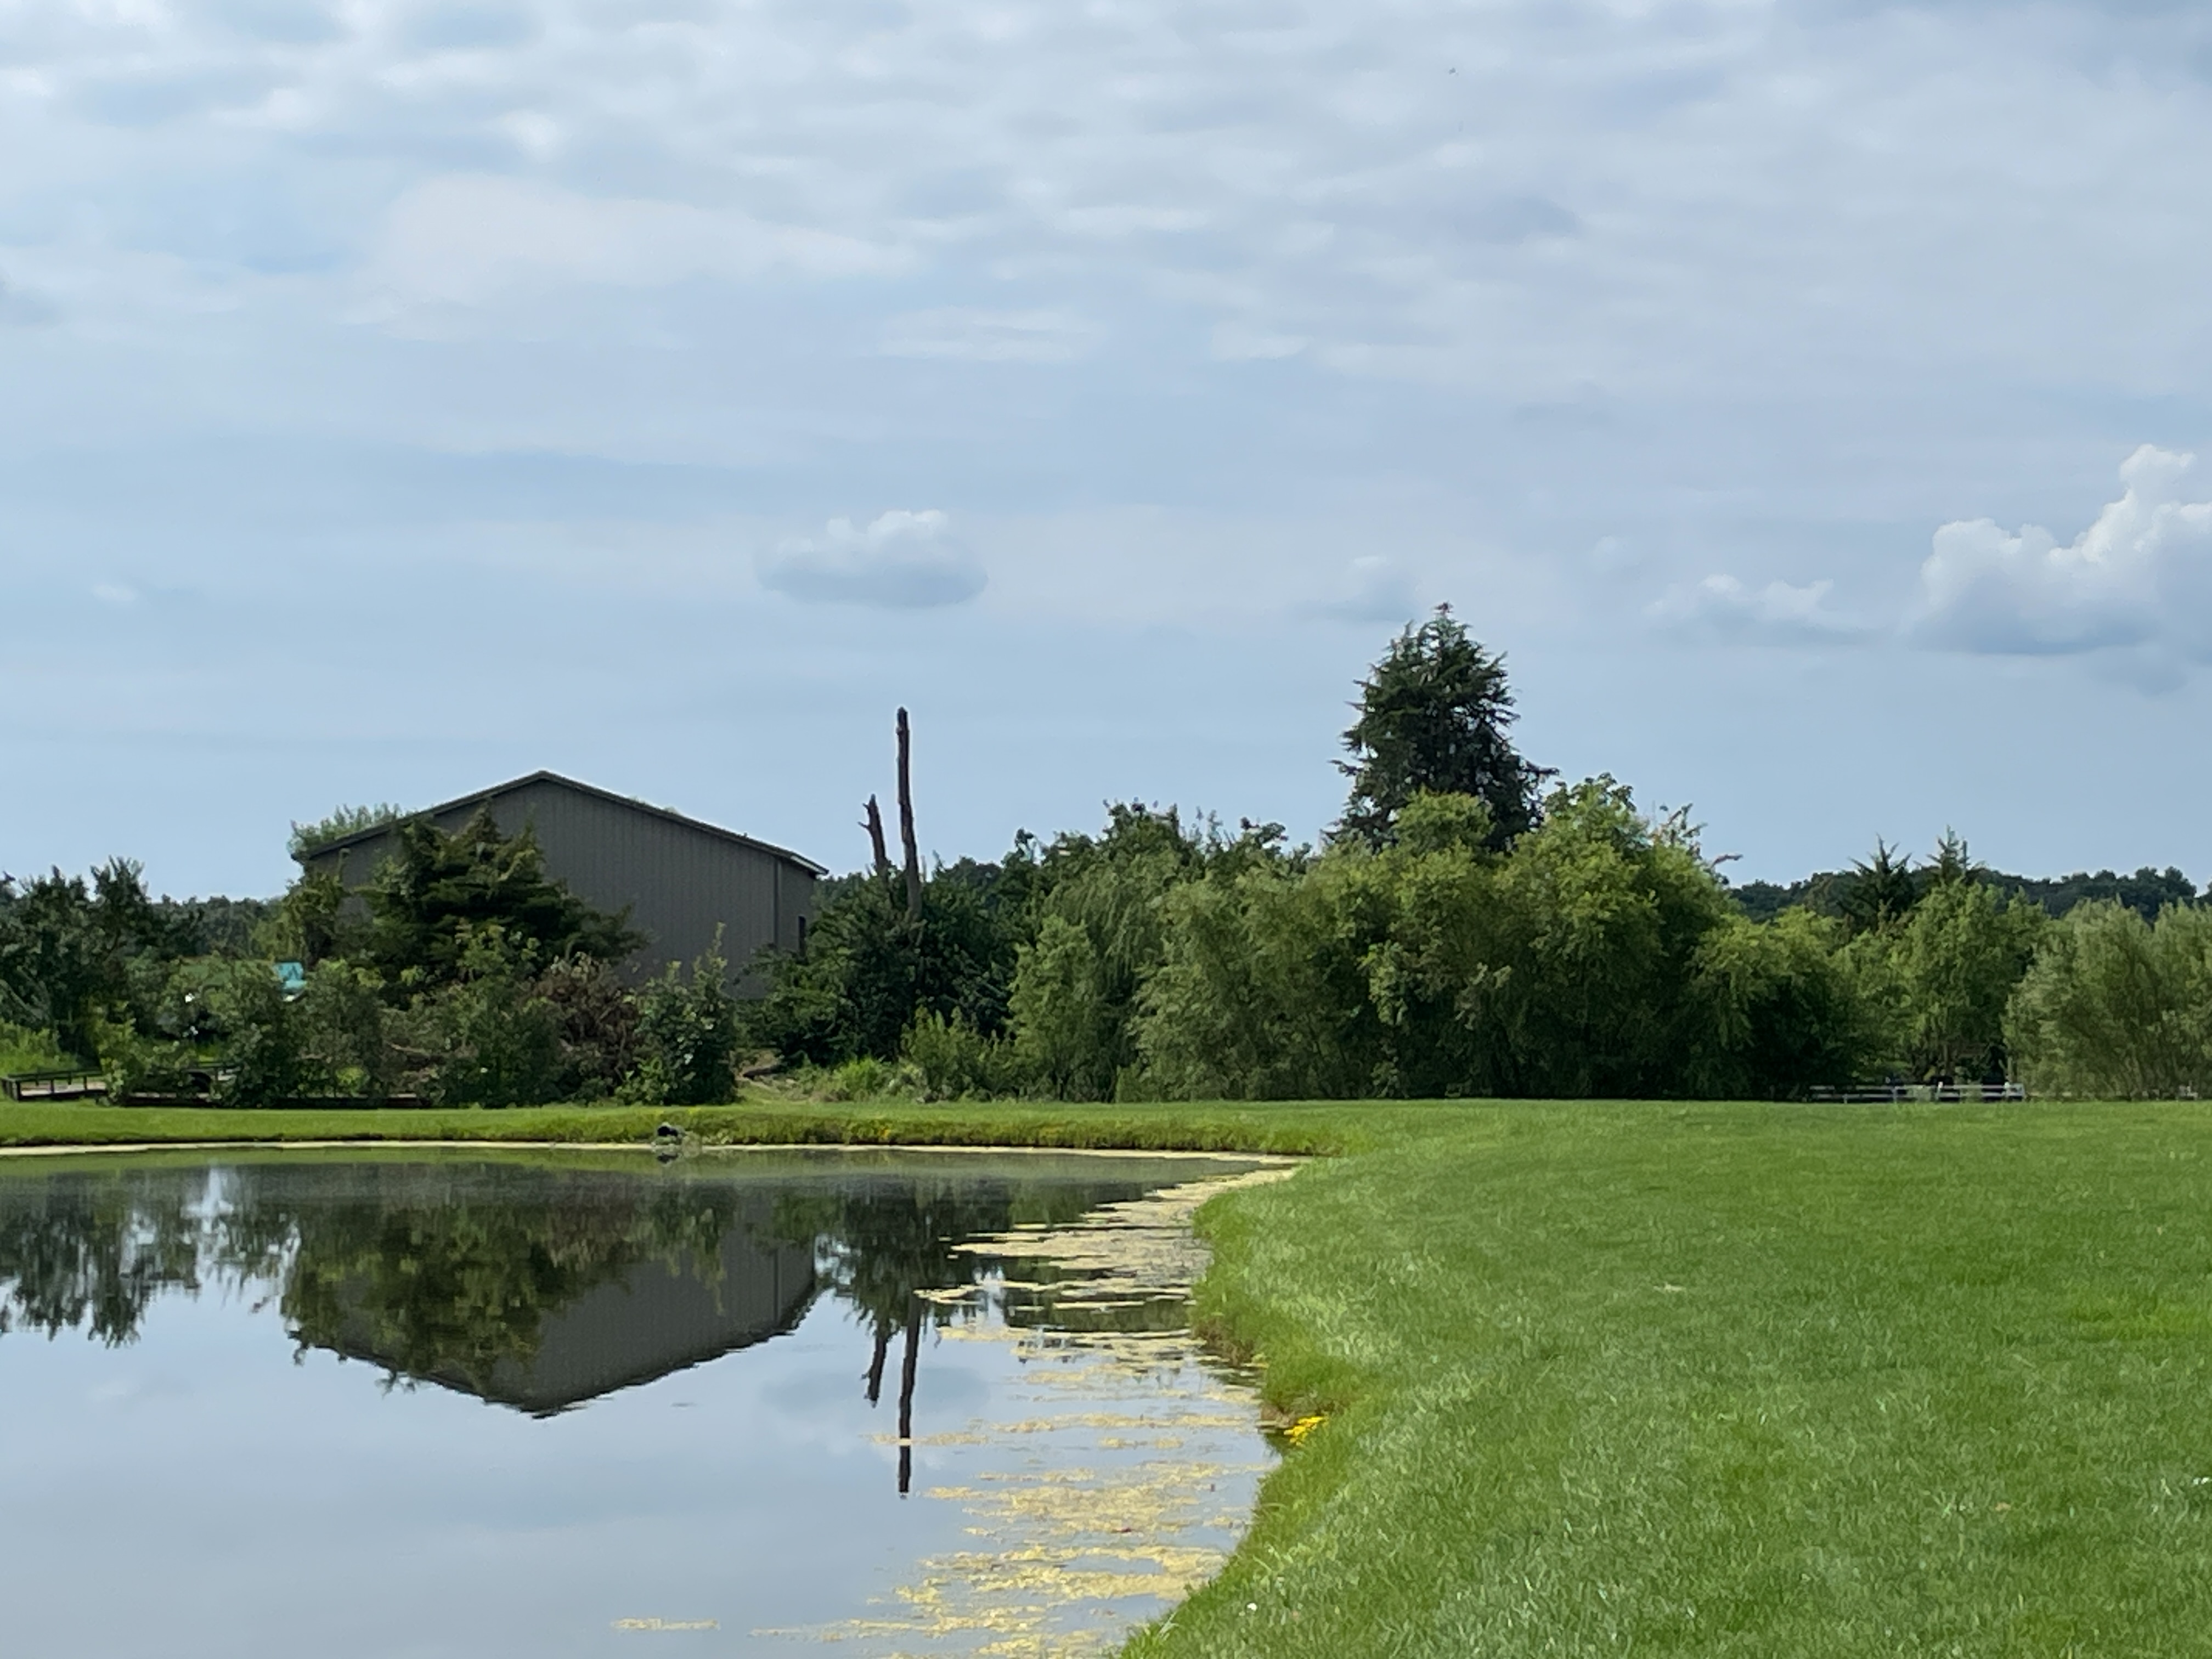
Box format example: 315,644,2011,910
358,810,644,986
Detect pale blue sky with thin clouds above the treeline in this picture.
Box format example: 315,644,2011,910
0,0,2212,896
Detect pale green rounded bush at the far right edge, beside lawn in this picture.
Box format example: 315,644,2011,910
2006,900,2212,1099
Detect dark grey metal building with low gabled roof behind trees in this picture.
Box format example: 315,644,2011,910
301,772,827,989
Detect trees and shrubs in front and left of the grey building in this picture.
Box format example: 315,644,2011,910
0,814,739,1106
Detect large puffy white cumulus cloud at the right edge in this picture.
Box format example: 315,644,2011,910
1907,444,2212,654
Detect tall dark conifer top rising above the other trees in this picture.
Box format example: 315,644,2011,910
1336,606,1550,847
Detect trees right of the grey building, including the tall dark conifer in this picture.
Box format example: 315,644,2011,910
750,611,2212,1099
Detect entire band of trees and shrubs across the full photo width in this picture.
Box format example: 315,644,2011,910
0,611,2212,1106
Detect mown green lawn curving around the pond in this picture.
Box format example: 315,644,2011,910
0,1104,2212,1659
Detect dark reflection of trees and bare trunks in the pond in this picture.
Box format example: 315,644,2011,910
0,1161,1194,1451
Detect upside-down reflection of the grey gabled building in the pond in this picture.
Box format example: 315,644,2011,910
328,1226,814,1415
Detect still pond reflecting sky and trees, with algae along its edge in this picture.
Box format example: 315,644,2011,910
0,1153,1276,1659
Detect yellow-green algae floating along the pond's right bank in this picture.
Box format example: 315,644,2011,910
778,1166,1290,1659
